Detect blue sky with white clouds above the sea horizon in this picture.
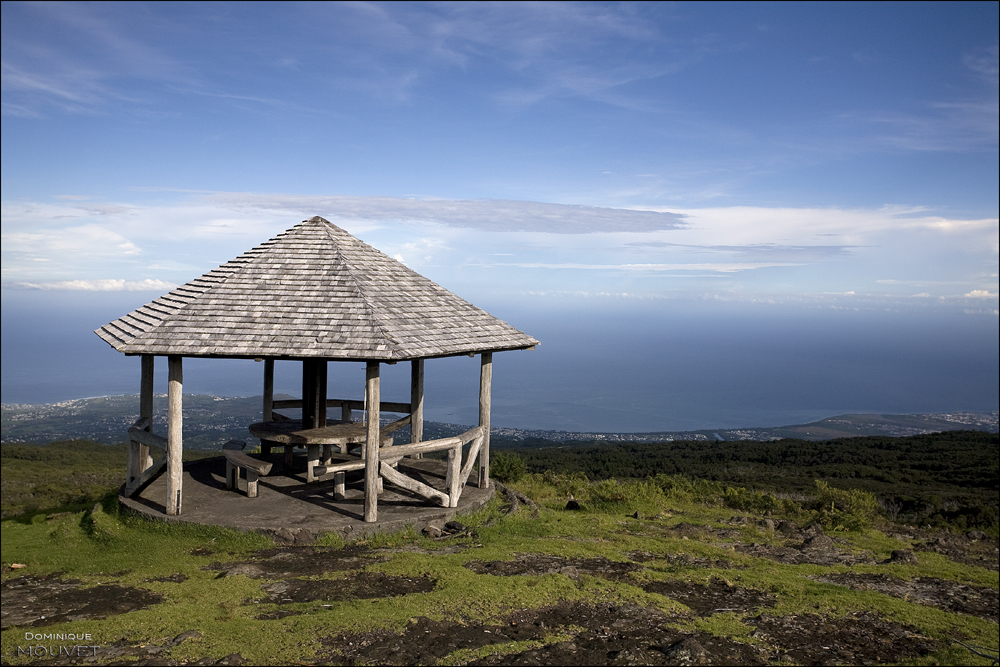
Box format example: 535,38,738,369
0,2,1000,428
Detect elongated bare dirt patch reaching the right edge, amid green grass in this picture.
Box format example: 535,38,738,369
816,572,1000,623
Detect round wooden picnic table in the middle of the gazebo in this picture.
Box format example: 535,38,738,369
250,419,392,482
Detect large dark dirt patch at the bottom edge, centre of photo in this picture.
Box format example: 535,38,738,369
321,602,765,665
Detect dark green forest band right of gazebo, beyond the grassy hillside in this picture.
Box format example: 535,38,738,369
498,431,1000,535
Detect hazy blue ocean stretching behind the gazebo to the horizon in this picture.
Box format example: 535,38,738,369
0,290,1000,432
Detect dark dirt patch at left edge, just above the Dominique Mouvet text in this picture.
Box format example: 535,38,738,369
0,573,163,630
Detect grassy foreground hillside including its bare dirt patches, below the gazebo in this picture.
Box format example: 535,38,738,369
0,473,1000,665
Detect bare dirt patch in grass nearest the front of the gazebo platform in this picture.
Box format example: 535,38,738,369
204,547,388,579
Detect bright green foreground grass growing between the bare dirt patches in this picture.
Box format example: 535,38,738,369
0,472,1000,665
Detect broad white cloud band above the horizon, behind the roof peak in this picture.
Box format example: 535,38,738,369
2,192,1000,298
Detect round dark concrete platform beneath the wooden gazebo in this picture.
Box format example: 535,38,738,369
118,453,494,543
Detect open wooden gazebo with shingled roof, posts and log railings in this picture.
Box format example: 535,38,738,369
95,217,538,522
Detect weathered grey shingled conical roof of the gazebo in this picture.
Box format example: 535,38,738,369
95,217,538,361
